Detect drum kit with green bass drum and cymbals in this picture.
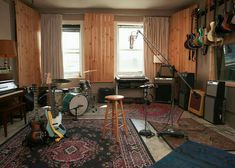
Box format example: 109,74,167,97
52,70,97,119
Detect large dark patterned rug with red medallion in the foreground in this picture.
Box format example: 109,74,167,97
0,119,154,168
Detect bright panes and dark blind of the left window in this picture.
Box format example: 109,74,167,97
62,24,82,78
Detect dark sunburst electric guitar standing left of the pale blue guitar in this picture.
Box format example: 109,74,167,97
30,84,46,143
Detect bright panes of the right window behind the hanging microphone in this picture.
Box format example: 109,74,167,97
117,24,144,76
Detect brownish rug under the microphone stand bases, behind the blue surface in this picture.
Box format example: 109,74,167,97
150,118,235,150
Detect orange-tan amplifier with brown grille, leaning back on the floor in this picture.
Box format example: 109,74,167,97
188,90,205,116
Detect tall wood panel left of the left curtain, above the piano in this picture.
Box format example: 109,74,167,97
15,0,41,87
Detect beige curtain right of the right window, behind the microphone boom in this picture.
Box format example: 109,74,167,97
144,17,169,81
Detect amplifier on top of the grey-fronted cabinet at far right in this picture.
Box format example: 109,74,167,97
206,81,225,99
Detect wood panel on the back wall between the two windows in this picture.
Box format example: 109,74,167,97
84,13,114,82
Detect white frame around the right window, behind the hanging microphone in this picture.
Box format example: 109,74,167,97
115,22,145,76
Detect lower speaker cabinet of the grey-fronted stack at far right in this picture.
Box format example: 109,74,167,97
204,95,224,124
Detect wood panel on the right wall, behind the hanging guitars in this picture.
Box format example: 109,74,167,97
169,5,196,73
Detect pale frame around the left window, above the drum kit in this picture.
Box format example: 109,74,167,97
61,20,84,80
